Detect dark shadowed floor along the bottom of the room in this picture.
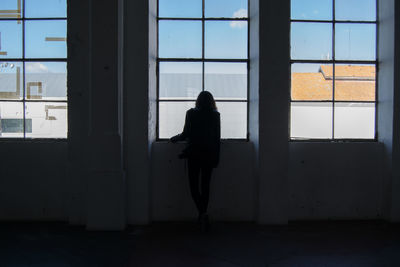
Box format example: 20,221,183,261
0,222,400,267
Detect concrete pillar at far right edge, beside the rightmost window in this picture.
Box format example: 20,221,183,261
377,0,400,222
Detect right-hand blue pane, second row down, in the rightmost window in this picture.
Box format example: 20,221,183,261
335,23,376,60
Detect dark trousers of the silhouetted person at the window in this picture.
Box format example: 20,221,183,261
188,159,213,214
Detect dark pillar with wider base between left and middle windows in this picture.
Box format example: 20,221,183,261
86,0,126,230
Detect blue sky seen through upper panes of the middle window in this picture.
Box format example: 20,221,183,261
159,0,248,73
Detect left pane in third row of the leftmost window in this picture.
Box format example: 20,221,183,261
0,62,23,99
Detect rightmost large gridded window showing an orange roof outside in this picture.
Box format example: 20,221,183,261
290,0,377,140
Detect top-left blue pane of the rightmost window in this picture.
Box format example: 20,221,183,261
291,0,332,20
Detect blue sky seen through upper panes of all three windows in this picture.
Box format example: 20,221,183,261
0,0,376,72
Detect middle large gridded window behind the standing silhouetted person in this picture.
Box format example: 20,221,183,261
157,0,248,139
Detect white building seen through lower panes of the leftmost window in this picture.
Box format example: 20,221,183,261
0,72,67,138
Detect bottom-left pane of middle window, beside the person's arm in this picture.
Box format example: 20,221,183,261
158,101,194,138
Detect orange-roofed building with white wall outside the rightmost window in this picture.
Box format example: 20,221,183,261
290,65,375,139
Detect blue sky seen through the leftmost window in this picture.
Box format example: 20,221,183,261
0,0,67,72
